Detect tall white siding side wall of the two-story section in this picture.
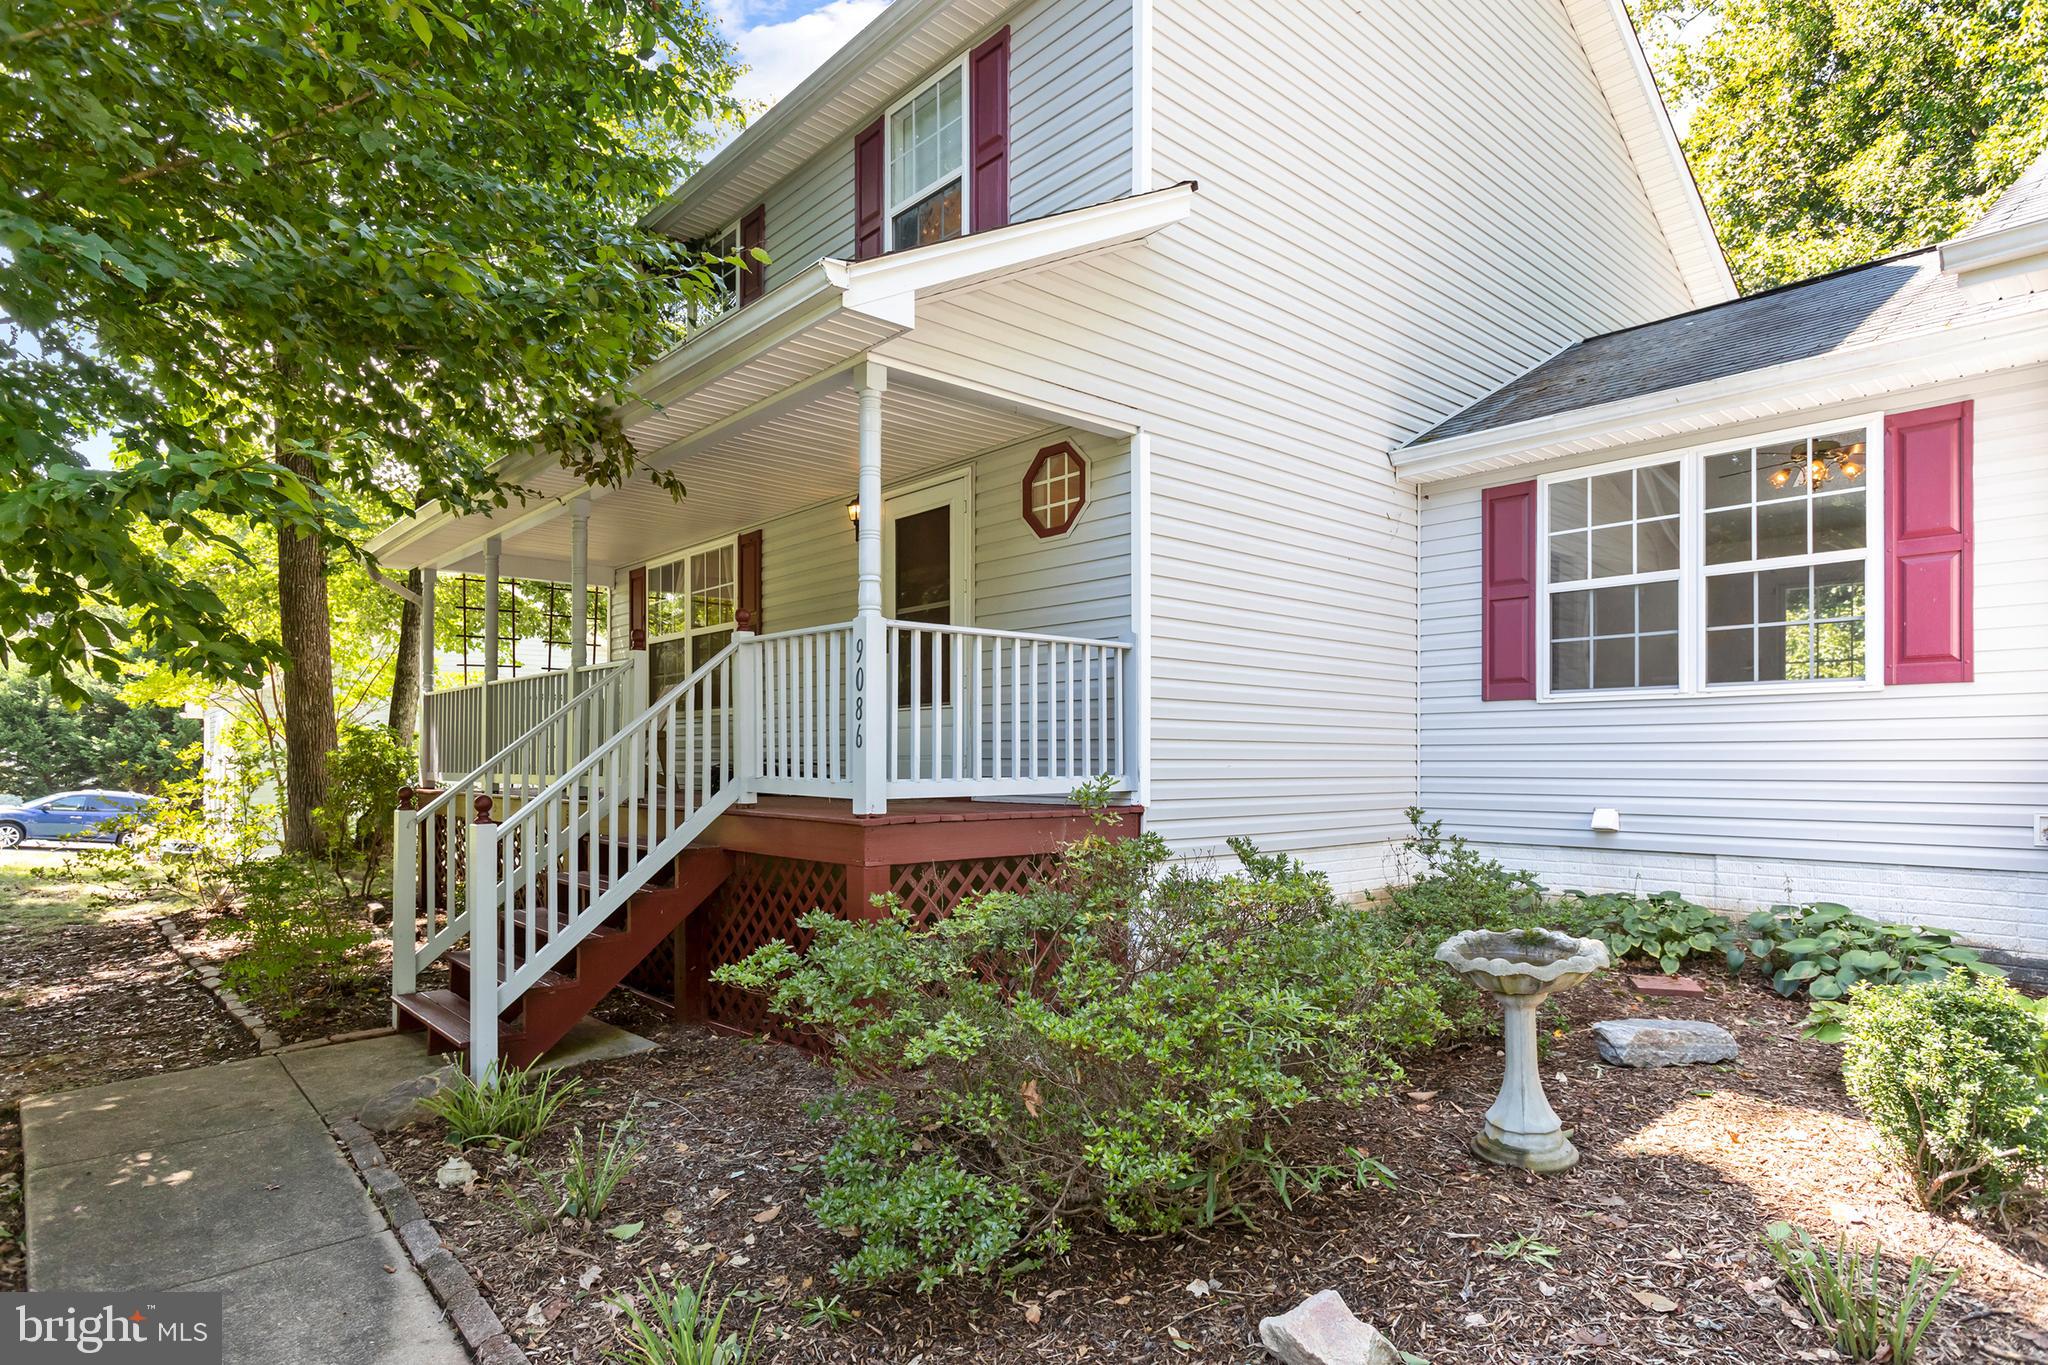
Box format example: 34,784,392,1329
881,0,1690,871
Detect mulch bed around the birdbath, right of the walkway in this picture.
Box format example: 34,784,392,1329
385,974,2048,1365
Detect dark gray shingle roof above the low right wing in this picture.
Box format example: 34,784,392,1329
1409,248,1982,446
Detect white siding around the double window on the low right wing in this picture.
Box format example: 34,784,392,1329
1421,368,2048,888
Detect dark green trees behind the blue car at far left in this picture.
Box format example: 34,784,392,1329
0,669,199,798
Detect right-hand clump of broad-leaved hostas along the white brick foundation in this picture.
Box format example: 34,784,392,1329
1729,902,2003,1001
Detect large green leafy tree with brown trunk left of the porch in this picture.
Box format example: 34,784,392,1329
0,0,733,847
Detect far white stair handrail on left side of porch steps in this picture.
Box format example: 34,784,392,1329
391,657,639,1019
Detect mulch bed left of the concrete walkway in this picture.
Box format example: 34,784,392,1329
0,871,256,1291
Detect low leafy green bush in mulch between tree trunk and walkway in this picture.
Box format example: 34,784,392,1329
207,857,375,1019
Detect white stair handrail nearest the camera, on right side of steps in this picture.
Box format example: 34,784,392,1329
467,630,760,1078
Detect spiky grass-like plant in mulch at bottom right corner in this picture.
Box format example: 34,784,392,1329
1763,1224,1962,1365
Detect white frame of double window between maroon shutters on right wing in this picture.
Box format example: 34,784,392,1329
1536,413,1886,706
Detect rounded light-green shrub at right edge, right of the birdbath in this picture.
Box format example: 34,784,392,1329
1841,972,2048,1209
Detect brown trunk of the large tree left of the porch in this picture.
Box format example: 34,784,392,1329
276,452,336,853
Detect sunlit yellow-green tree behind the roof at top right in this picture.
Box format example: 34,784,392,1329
1630,0,2048,291
